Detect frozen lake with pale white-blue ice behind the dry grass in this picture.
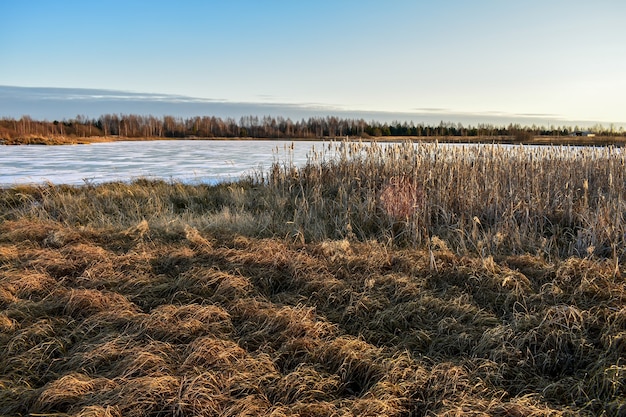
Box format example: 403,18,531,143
0,140,323,187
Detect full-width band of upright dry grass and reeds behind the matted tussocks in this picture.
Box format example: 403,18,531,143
6,143,626,260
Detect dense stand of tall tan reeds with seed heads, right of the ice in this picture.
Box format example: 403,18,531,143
260,142,626,258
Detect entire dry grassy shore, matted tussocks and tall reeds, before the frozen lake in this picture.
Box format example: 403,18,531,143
0,144,626,416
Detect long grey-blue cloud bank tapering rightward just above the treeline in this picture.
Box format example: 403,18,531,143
0,86,626,127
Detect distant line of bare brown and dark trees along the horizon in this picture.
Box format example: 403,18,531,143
0,114,626,141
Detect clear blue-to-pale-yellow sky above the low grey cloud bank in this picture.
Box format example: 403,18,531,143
0,0,626,123
